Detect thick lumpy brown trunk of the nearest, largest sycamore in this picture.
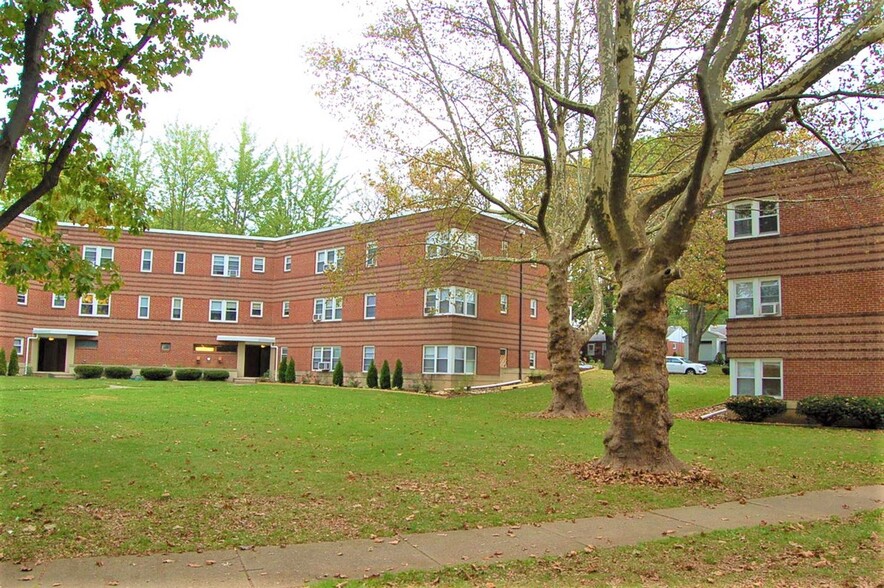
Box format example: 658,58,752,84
602,277,685,472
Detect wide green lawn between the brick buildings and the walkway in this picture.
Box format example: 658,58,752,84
0,372,882,560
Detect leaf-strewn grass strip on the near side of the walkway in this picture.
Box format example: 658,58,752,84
326,511,884,588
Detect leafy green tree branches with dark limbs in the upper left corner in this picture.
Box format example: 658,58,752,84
0,0,236,294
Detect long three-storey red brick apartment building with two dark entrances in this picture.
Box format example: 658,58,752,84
0,213,548,389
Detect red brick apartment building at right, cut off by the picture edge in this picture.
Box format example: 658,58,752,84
724,146,884,405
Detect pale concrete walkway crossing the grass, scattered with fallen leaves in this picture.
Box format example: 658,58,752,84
0,485,884,588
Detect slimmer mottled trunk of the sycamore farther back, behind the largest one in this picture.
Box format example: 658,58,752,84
546,260,588,417
